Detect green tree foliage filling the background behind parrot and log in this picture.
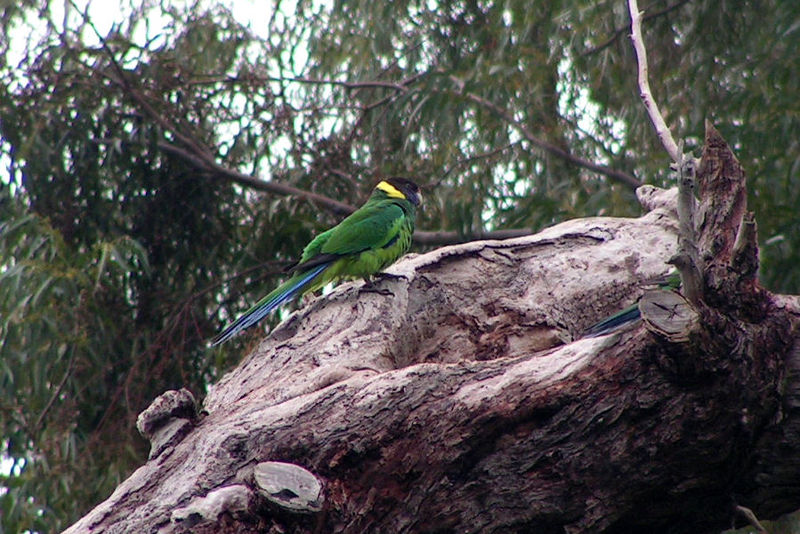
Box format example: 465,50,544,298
0,0,800,532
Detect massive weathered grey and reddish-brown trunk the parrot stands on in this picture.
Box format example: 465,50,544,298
69,129,800,533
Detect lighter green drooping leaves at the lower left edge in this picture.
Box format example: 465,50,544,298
0,206,149,532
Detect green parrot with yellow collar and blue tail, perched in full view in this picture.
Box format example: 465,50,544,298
212,178,422,345
